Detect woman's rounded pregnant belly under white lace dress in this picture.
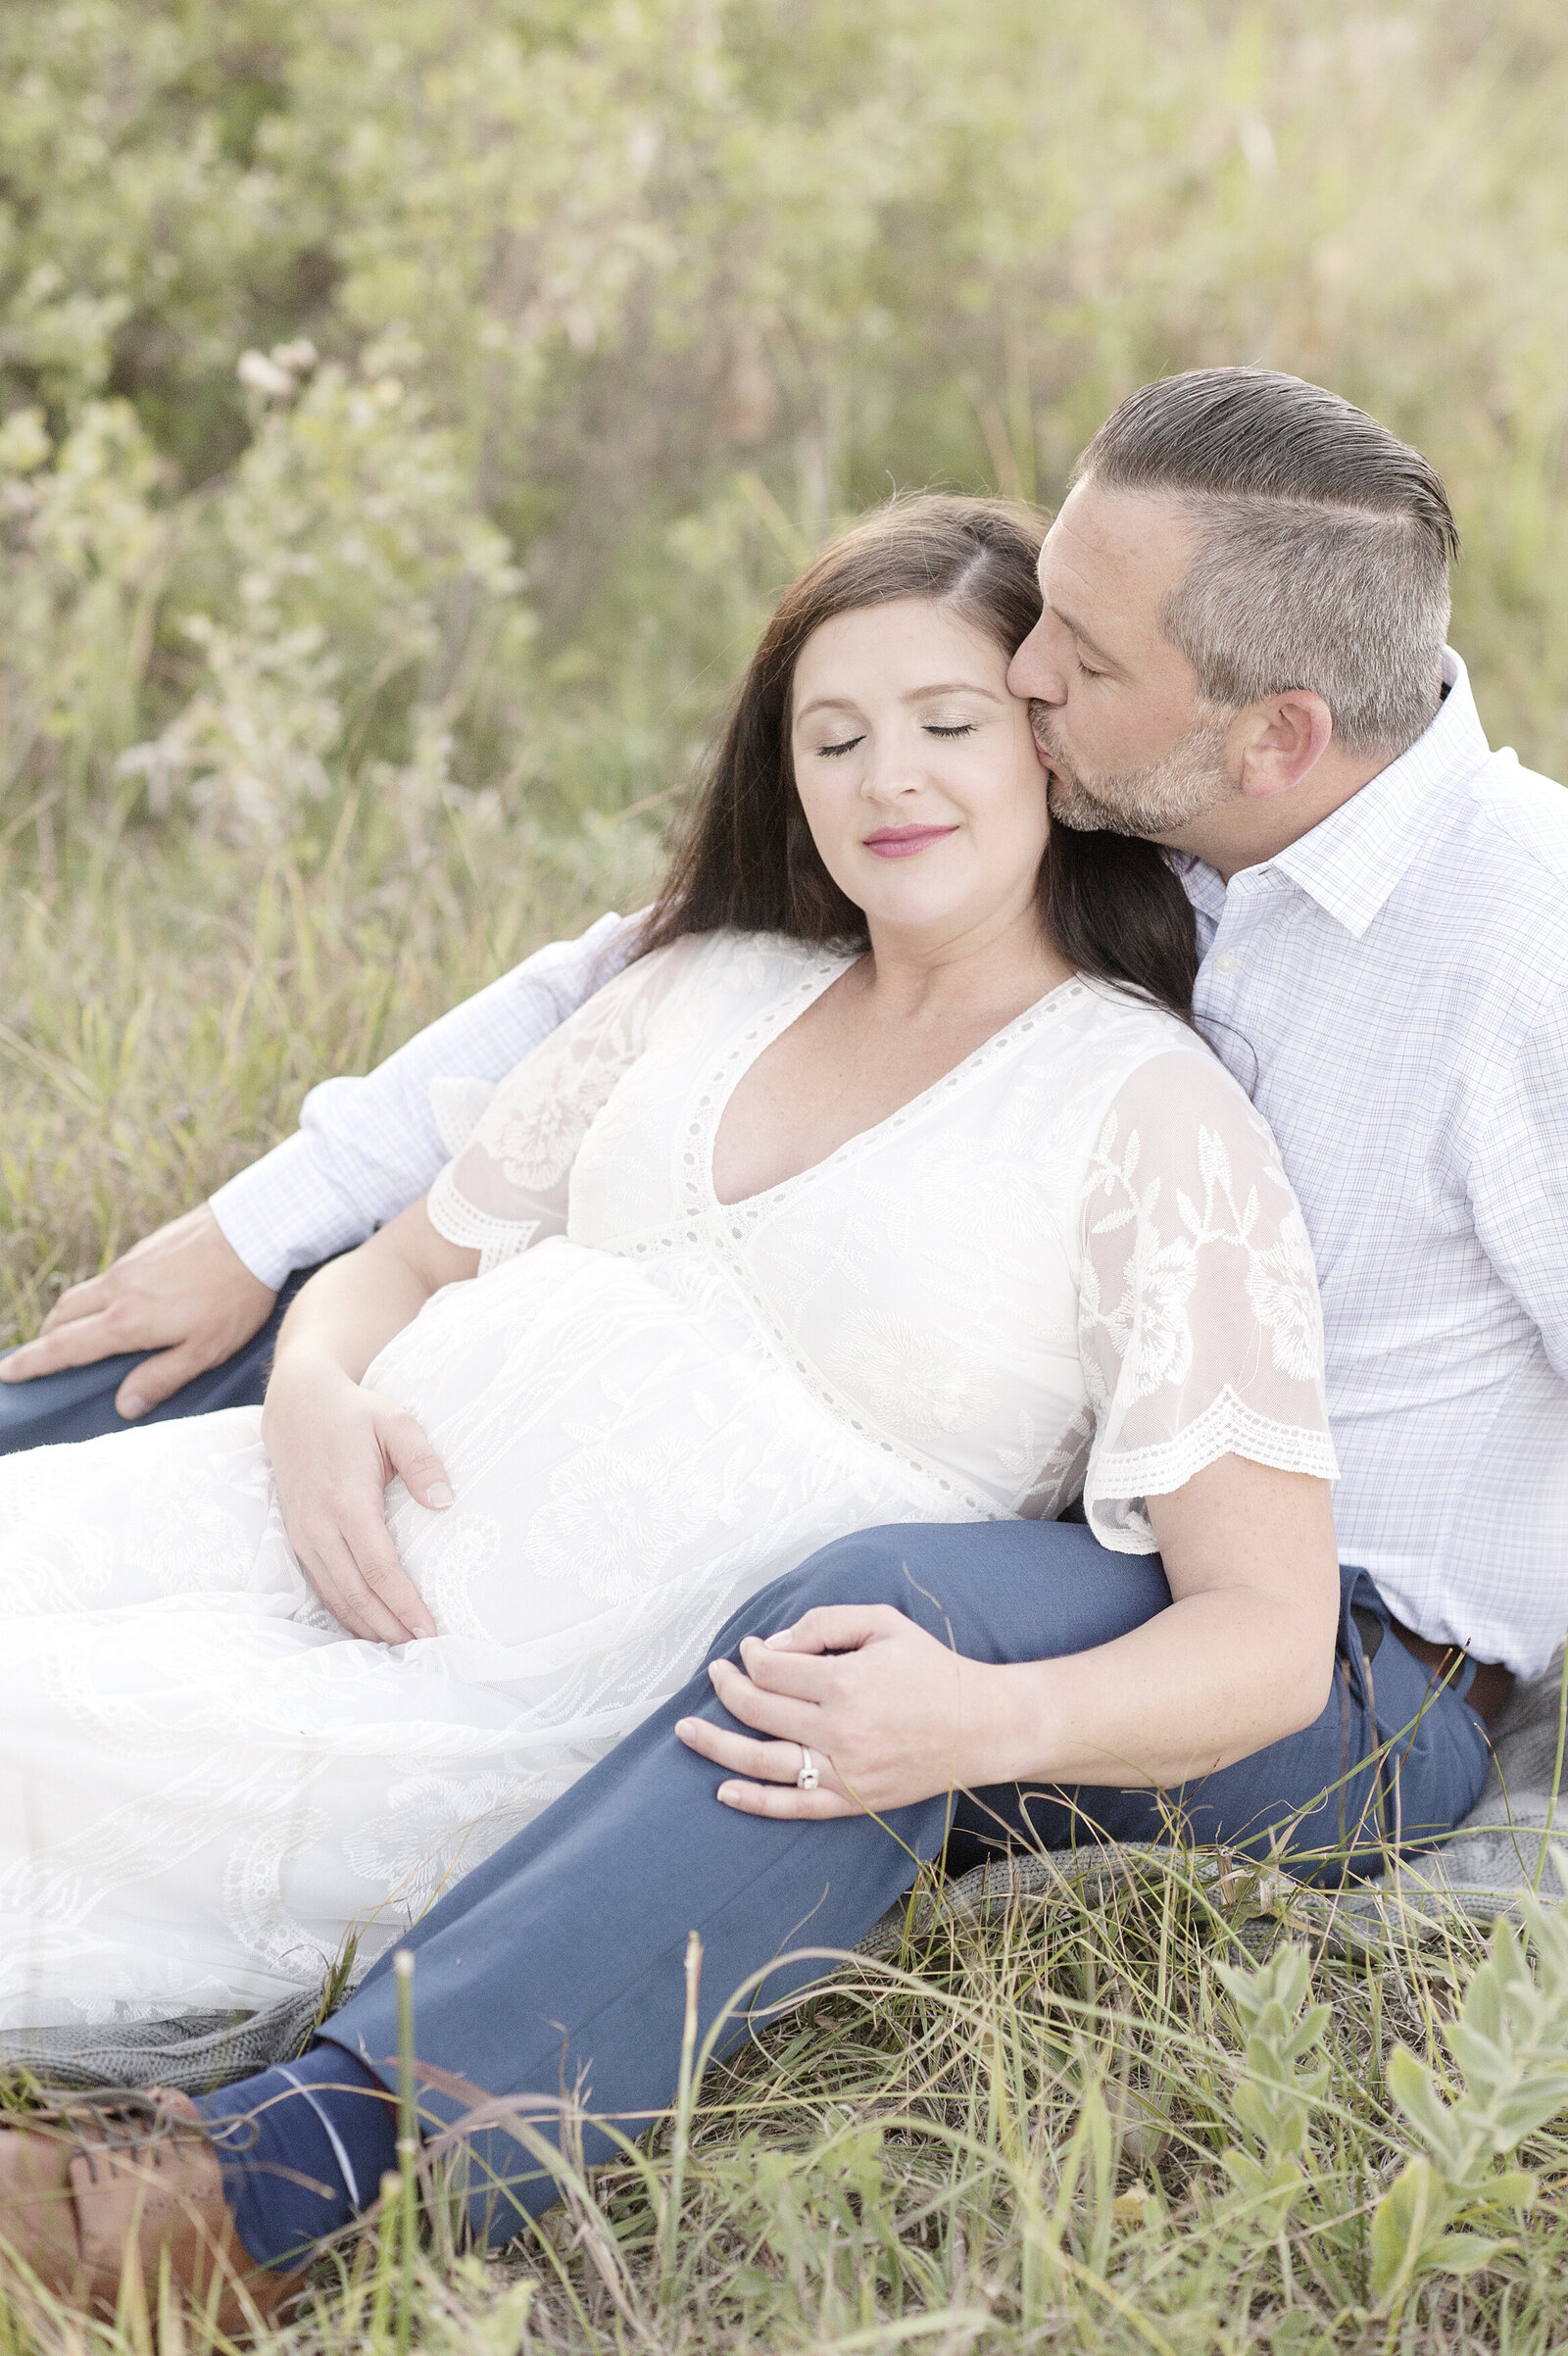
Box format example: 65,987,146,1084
368,1240,932,1698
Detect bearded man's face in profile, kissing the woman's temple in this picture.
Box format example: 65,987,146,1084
1007,480,1241,839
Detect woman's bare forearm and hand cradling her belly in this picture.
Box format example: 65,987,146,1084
262,1202,478,1644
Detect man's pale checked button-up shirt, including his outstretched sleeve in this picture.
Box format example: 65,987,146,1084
215,655,1568,1675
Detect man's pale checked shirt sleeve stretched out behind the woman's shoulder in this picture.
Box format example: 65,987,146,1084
212,914,638,1291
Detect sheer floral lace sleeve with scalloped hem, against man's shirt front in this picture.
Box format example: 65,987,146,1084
1078,1049,1340,1555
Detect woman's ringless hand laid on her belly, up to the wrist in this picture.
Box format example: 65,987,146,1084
262,1357,452,1644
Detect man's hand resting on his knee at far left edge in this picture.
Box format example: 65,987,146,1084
0,1203,277,1421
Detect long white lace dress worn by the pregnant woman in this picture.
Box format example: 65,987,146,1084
0,933,1335,2026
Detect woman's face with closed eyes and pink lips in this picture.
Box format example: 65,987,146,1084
791,599,1050,945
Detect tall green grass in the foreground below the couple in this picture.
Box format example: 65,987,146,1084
0,1852,1568,2356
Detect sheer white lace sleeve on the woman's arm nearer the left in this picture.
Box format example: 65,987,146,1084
428,940,690,1275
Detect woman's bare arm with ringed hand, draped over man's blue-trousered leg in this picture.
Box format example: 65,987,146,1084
678,1456,1340,1816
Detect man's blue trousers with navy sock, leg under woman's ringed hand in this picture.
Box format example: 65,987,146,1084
203,1522,1488,2264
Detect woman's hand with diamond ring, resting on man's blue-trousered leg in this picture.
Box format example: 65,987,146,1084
675,1604,999,1819
